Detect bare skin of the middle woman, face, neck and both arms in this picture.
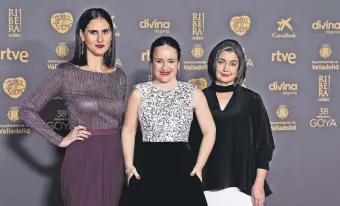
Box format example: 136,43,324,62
122,45,216,182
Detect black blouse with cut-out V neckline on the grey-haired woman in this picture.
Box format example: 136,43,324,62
190,85,275,196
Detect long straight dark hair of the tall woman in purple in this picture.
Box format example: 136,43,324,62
70,8,116,68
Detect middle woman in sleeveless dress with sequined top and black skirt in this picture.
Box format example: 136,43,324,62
122,37,215,206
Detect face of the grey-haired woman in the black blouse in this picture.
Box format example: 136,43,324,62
216,51,239,86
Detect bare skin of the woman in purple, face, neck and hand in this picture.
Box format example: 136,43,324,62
59,18,116,147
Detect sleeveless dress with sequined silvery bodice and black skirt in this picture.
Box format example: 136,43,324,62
124,82,207,206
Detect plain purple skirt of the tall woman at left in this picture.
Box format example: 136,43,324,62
61,129,124,206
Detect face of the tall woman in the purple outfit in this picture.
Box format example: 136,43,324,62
80,18,112,56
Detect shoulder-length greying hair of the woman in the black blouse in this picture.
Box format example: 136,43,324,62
208,39,247,85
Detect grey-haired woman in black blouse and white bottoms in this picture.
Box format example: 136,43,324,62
190,39,275,206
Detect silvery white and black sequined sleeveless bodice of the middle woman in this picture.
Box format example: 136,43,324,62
134,81,197,142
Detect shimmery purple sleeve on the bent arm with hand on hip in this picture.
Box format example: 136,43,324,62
20,65,64,145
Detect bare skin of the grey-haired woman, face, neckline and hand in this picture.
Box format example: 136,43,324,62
215,51,267,206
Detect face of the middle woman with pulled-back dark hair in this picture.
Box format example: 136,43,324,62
151,45,180,83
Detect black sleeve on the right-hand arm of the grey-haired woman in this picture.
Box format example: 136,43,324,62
252,95,275,170
